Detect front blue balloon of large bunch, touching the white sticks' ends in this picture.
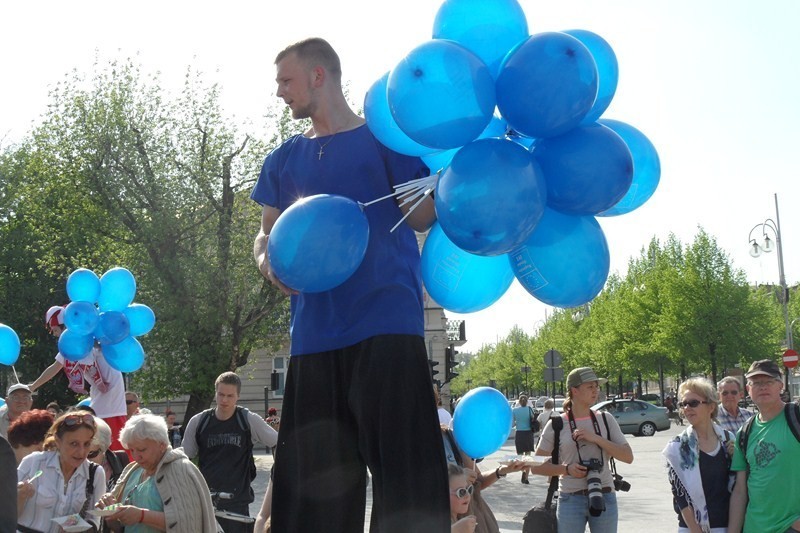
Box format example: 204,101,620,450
434,139,547,255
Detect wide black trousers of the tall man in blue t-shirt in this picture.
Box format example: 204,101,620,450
272,335,450,533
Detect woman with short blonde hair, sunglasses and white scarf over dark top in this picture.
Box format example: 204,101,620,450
662,378,734,533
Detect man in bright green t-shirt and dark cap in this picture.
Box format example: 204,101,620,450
728,359,800,533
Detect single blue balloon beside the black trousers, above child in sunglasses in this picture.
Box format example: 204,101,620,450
453,387,511,459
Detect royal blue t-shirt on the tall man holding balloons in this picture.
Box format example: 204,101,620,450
250,125,429,355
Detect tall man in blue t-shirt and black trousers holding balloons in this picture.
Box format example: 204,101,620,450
251,38,450,533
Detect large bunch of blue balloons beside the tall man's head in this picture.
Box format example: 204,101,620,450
364,0,660,313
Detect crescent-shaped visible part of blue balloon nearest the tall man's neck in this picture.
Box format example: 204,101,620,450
364,72,438,156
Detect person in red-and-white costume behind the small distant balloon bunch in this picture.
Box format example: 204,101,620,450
30,305,127,450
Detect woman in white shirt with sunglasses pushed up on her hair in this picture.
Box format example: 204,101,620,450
17,411,105,533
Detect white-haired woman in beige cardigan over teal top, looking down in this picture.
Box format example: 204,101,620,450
100,414,217,533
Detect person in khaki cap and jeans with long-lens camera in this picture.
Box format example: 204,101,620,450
531,367,633,533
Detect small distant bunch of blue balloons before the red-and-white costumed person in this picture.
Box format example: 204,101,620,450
58,267,156,372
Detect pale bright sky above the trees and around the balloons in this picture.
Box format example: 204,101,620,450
0,0,800,352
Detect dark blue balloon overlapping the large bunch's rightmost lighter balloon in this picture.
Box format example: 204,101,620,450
533,124,633,215
